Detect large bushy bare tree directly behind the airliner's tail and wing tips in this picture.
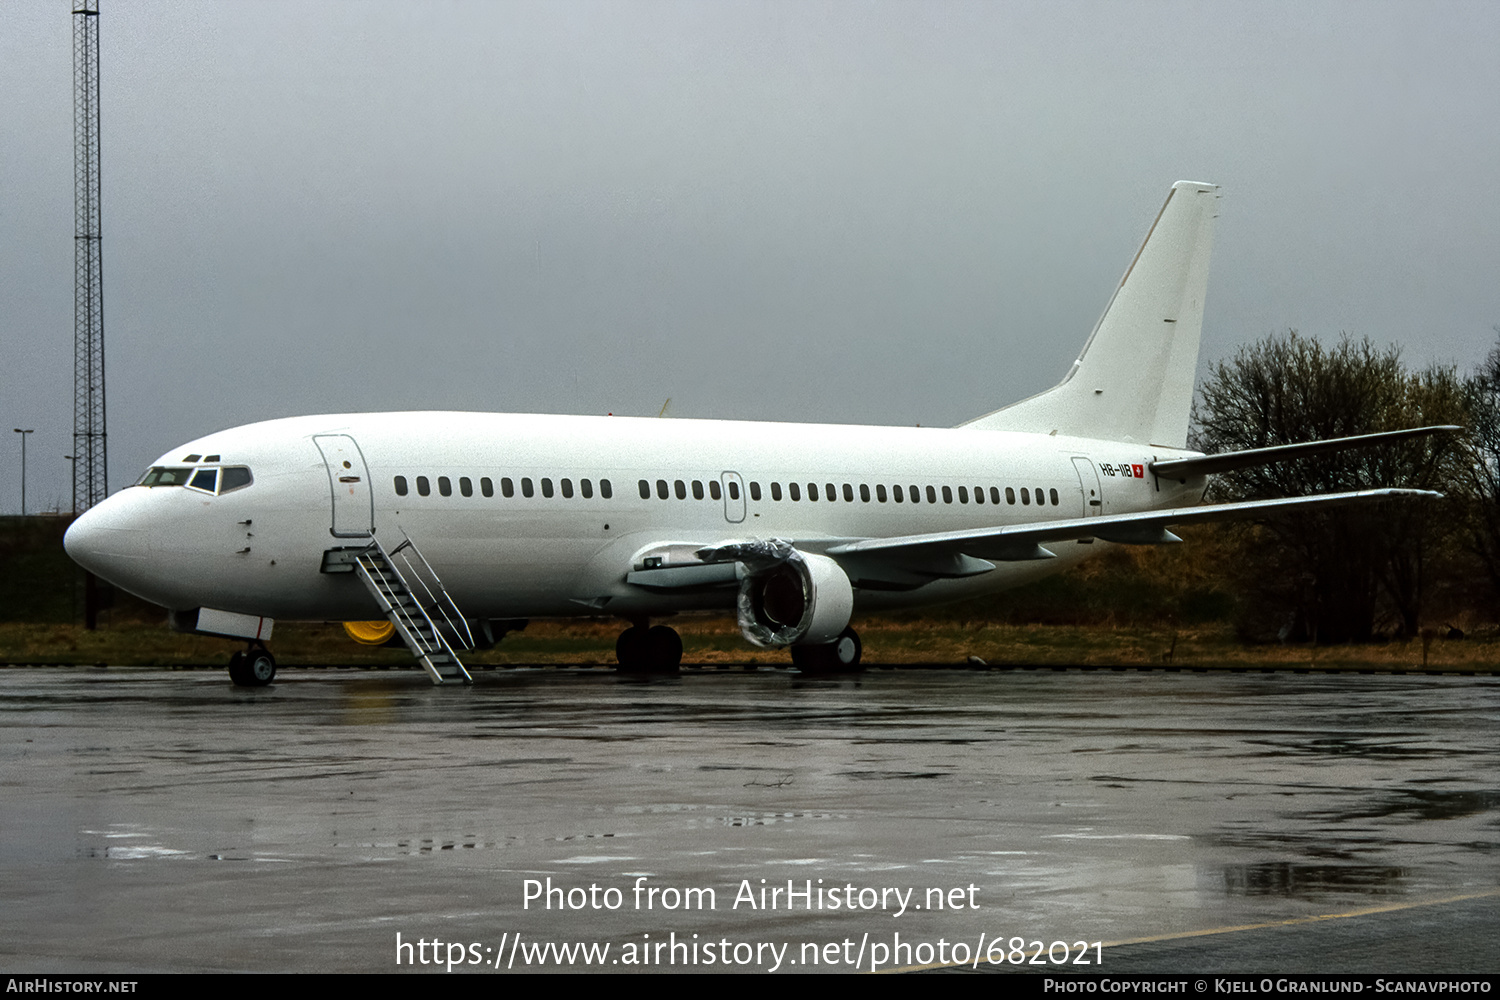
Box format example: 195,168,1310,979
1194,331,1466,642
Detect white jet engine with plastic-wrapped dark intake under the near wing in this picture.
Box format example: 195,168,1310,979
738,546,854,646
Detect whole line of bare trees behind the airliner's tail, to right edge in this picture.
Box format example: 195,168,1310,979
1190,331,1500,642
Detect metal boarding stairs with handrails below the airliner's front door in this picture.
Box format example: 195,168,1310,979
354,538,474,684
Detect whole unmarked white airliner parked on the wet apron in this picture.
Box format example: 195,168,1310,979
66,181,1439,685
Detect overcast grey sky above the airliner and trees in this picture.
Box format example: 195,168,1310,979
0,0,1500,513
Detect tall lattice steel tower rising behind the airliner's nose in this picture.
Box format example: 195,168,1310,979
74,0,110,514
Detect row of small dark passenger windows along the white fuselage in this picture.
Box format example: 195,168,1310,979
396,475,1061,507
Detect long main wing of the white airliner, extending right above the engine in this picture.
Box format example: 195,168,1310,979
827,489,1442,562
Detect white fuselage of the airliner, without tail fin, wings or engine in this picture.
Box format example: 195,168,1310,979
69,412,1203,621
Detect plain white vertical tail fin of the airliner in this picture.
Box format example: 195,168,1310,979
963,180,1220,448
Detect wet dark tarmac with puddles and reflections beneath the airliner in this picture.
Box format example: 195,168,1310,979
0,669,1500,975
